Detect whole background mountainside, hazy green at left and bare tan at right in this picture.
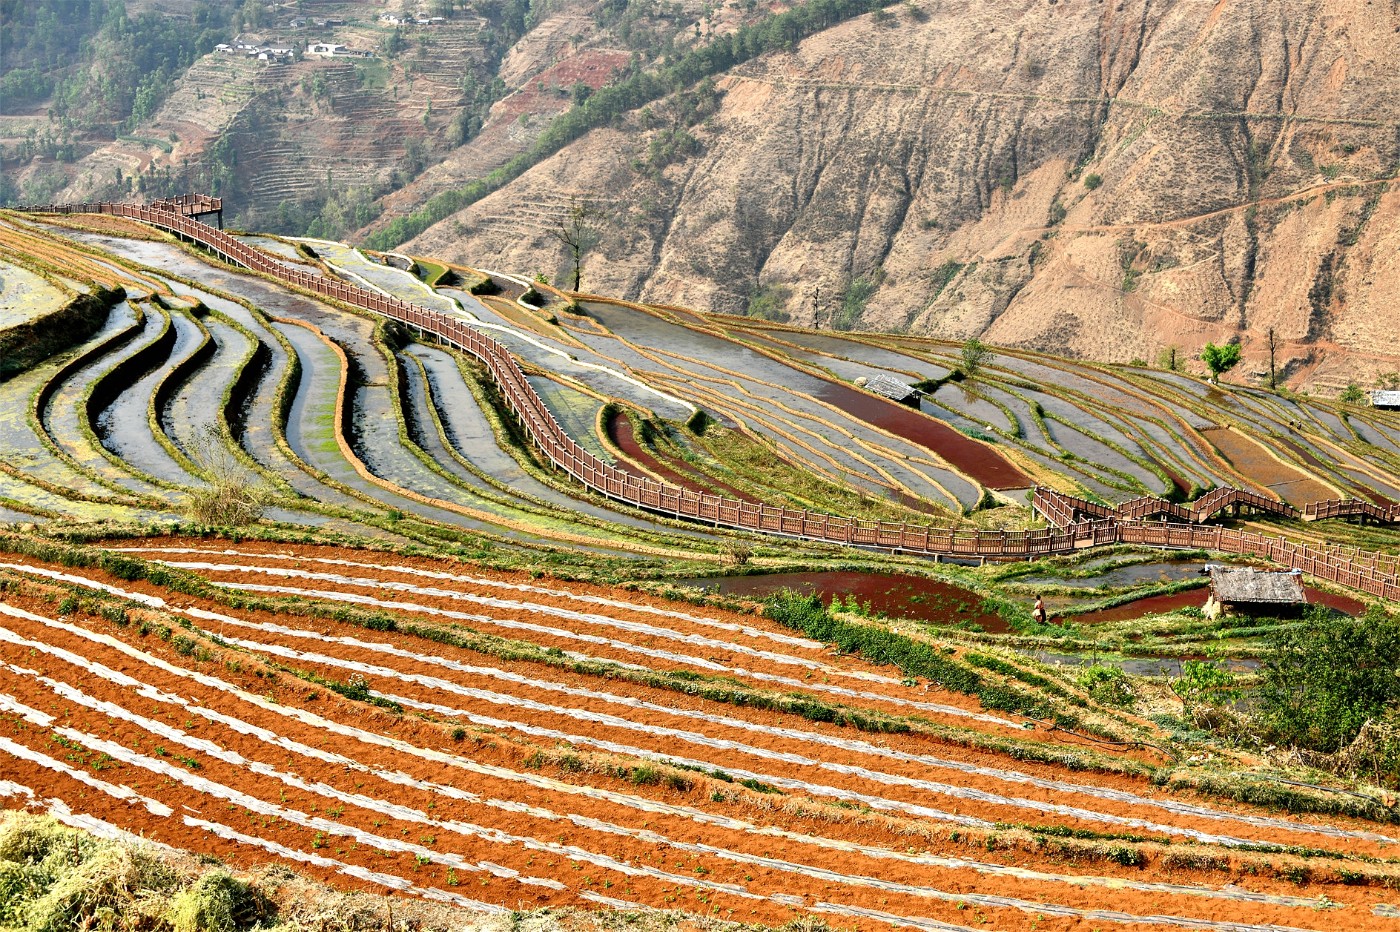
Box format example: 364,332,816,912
10,0,1400,395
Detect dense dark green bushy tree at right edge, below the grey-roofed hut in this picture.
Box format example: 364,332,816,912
1256,607,1400,753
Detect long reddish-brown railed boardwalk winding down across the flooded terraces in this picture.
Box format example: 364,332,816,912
25,199,1400,602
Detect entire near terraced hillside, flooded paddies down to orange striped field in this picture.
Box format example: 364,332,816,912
0,196,1400,932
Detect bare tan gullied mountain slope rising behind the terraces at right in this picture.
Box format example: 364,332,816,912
409,0,1400,389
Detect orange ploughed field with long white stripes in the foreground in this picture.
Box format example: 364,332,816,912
0,547,1400,932
